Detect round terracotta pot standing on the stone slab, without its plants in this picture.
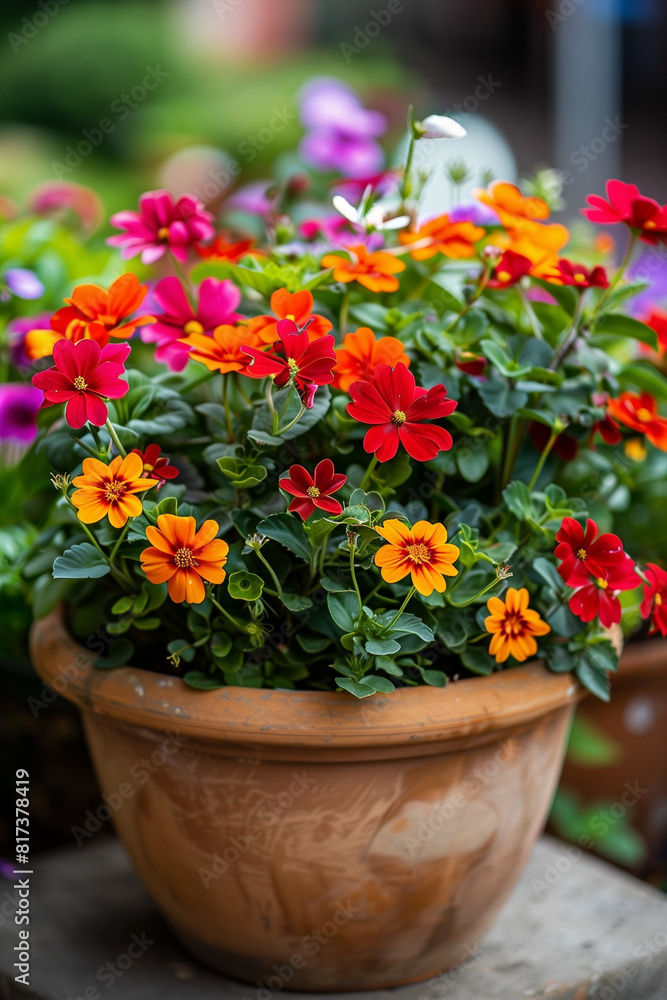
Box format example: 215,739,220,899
32,612,580,990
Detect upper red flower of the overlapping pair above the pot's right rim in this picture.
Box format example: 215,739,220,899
554,517,639,590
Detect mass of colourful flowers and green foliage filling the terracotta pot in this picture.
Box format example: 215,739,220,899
17,95,667,698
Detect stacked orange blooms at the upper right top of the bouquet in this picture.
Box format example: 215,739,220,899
473,181,570,279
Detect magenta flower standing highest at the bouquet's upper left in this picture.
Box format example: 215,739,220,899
107,191,215,264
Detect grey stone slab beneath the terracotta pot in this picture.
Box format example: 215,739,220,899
0,838,667,1000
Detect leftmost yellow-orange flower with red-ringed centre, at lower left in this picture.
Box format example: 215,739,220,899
72,452,155,528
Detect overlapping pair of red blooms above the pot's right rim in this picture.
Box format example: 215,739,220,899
554,517,641,628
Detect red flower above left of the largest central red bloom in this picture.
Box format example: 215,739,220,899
241,319,336,409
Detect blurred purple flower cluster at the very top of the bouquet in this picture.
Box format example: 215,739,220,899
299,77,387,177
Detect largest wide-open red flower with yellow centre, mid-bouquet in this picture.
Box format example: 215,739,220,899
347,362,457,462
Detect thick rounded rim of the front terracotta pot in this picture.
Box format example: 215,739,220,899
30,606,585,749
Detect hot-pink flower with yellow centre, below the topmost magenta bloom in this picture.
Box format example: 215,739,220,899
141,278,242,372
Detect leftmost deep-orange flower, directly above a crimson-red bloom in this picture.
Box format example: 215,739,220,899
25,274,155,360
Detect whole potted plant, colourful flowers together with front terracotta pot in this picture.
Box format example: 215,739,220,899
22,88,667,990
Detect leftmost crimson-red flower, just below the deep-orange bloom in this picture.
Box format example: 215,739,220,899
32,340,130,427
